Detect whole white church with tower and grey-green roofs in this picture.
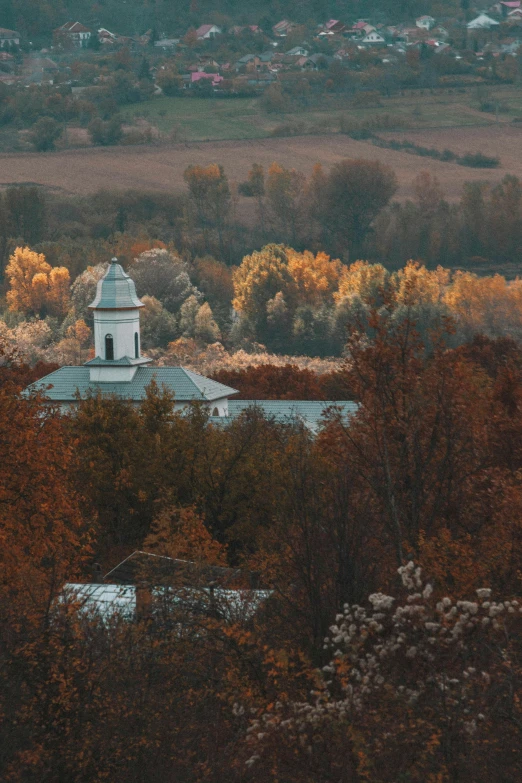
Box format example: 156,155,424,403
26,258,357,431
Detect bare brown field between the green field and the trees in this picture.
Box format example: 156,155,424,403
0,124,522,200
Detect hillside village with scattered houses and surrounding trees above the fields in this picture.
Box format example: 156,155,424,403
0,0,522,150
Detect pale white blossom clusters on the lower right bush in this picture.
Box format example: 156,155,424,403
243,562,522,765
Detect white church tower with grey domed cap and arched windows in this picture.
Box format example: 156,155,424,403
86,258,151,383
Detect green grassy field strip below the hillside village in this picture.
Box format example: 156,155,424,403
115,86,522,142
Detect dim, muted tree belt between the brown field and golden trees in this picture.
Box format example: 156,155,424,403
0,160,522,276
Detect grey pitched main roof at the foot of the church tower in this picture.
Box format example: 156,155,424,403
26,366,237,402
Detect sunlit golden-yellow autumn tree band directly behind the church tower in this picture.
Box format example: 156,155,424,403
5,241,522,364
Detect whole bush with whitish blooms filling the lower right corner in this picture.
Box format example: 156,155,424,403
243,562,522,783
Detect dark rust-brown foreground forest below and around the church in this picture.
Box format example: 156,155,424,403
0,312,522,783
